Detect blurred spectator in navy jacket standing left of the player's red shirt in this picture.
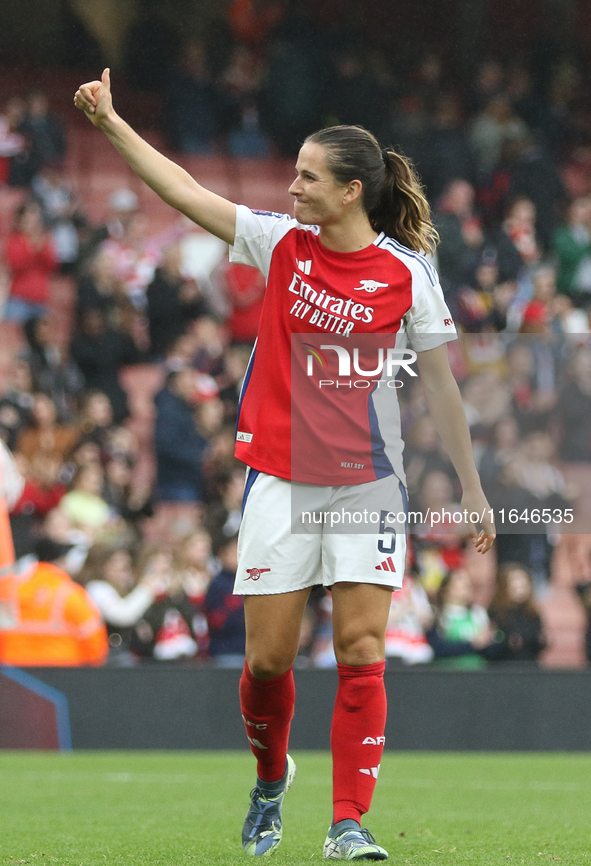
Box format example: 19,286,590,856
154,370,206,502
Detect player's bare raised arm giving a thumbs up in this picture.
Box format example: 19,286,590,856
74,69,236,244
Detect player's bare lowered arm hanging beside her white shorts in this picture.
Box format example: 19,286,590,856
417,344,496,553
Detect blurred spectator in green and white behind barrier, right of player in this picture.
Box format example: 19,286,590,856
427,568,493,670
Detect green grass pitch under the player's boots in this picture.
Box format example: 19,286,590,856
0,752,591,866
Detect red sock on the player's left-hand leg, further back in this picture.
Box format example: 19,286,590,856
240,663,295,782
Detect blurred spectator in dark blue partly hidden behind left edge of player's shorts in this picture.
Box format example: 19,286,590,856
205,537,246,668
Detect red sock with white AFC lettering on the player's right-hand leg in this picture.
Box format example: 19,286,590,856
330,662,386,824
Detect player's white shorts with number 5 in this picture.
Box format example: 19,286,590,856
234,469,407,595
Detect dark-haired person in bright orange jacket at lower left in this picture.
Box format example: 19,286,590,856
0,538,109,667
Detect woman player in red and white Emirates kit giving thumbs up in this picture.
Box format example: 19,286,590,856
75,70,494,860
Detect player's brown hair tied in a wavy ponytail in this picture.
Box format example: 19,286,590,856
305,126,439,253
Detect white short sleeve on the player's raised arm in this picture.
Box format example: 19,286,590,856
230,204,298,279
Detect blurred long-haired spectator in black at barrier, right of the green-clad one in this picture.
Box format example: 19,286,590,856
488,562,546,663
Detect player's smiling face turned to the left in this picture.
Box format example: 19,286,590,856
289,142,361,226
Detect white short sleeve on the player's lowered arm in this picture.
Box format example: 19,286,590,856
405,255,458,352
